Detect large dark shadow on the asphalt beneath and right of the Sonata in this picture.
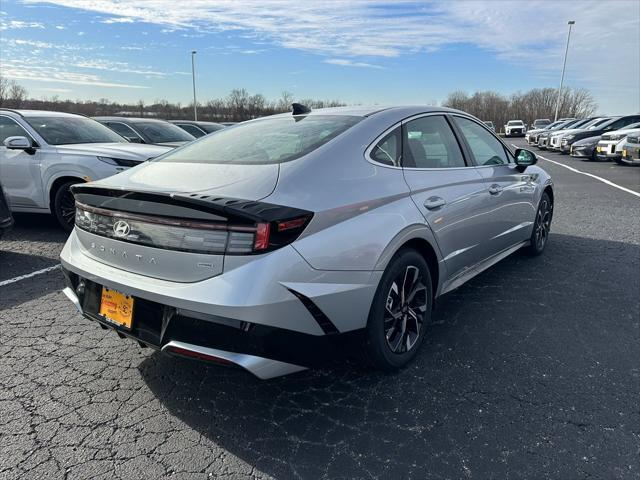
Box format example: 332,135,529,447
139,234,640,479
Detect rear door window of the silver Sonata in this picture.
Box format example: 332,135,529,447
402,115,466,168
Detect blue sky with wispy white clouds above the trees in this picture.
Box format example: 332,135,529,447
0,0,640,114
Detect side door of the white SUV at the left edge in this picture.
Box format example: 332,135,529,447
0,115,44,209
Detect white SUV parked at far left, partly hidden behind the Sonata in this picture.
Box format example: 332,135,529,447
0,108,170,230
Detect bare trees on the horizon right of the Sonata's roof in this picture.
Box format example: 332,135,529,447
443,88,598,131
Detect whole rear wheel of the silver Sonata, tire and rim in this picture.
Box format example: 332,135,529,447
365,248,433,372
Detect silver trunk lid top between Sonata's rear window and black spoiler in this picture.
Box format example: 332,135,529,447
94,161,279,200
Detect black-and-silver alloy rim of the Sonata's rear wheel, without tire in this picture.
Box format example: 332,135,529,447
384,265,427,353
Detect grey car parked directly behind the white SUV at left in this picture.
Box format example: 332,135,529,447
93,117,196,147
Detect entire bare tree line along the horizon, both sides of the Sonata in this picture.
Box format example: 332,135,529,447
0,76,597,131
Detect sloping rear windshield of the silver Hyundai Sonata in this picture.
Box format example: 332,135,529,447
157,115,361,165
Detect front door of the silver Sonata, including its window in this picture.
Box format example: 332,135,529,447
453,115,537,255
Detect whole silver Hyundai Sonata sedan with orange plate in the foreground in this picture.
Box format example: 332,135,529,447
61,104,554,378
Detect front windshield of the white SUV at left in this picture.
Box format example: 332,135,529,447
25,117,127,145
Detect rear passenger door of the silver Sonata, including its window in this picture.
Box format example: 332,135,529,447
402,114,488,280
